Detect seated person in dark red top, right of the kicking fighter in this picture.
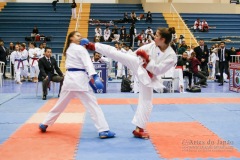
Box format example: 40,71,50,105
189,52,207,87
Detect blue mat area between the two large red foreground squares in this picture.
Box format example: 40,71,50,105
76,105,161,160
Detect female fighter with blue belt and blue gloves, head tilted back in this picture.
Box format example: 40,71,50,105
39,31,115,138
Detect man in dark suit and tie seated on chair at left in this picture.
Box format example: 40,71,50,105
38,47,63,100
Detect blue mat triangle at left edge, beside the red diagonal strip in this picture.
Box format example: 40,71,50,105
0,93,46,145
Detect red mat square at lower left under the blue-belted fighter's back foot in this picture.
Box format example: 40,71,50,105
0,124,82,160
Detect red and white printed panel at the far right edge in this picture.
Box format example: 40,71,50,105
229,63,240,92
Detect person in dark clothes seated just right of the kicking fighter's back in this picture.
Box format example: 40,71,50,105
177,52,192,89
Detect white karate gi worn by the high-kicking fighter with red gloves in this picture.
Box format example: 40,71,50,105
95,42,177,128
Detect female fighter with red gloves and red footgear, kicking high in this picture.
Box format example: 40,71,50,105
87,28,177,139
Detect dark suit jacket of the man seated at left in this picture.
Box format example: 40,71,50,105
38,57,63,80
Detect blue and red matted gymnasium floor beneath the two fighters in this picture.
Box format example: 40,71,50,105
0,80,240,160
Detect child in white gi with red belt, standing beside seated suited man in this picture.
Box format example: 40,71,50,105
28,42,41,82
